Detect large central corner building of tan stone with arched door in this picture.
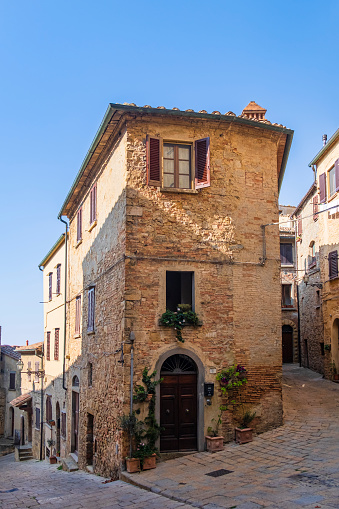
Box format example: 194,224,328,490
59,100,293,475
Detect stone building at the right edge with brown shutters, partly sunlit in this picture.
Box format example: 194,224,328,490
294,129,339,378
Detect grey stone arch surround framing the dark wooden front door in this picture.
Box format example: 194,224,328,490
155,346,205,451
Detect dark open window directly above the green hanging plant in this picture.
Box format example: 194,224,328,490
166,271,194,311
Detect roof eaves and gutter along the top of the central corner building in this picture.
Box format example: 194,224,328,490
58,103,294,215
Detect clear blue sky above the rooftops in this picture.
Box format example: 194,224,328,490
0,0,339,344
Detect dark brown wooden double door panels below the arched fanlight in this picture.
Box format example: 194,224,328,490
160,374,197,452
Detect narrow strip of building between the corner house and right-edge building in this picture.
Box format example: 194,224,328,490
279,205,299,363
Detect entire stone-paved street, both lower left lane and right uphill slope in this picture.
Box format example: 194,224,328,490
0,365,339,509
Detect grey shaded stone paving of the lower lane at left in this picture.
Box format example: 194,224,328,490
0,454,192,509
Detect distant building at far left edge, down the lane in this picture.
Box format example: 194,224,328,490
0,345,20,440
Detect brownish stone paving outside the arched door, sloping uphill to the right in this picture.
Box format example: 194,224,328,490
125,365,339,509
